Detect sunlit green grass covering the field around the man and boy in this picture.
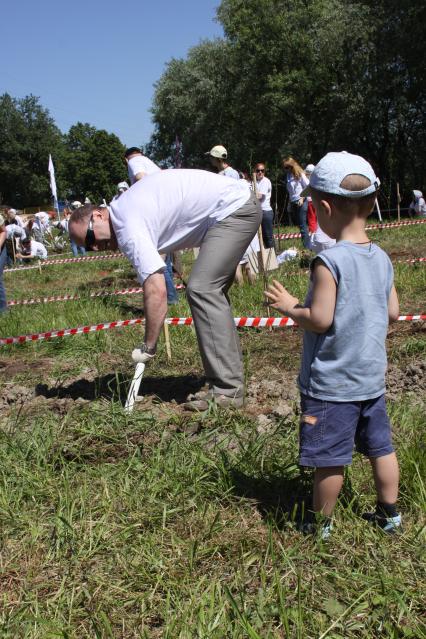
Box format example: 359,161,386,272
0,222,426,639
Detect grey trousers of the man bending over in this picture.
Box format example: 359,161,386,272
186,195,262,397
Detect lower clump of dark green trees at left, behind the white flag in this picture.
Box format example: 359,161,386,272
0,93,126,207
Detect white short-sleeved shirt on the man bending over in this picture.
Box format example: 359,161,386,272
109,169,250,283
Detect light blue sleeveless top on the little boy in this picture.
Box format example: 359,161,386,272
299,241,393,402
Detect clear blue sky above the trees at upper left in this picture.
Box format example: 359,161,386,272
0,0,222,146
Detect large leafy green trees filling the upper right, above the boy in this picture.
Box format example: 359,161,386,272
151,0,426,199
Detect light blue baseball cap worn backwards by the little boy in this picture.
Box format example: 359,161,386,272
302,151,380,198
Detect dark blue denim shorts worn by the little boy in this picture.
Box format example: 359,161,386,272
299,395,394,468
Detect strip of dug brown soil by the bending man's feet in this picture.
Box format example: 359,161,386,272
0,360,426,424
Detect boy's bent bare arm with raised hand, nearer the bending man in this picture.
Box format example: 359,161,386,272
265,261,336,333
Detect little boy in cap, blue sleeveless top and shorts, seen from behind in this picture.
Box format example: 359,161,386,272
266,152,401,539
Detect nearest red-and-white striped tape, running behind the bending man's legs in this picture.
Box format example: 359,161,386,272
0,313,426,346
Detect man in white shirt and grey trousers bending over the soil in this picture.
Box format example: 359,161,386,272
69,169,261,410
